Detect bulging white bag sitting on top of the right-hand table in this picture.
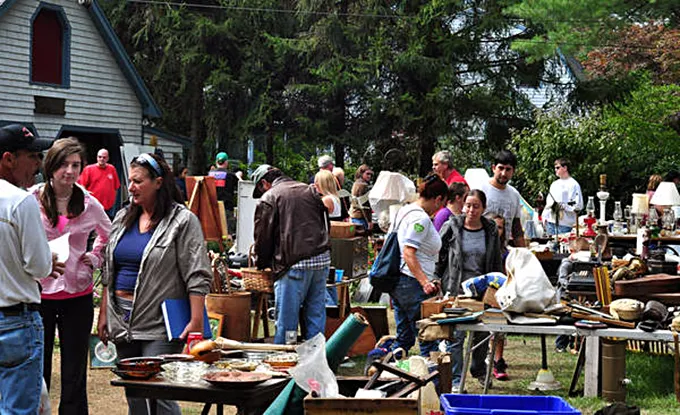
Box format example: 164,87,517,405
496,248,558,313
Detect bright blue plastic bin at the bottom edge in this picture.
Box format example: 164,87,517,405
440,393,581,415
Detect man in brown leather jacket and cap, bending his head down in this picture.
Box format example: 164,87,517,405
251,164,331,344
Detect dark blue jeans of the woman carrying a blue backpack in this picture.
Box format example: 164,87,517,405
390,274,438,357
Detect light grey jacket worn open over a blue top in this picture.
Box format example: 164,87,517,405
102,203,212,342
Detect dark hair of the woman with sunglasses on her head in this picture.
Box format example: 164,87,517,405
123,153,184,229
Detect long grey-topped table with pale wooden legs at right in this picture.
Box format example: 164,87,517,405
446,323,673,397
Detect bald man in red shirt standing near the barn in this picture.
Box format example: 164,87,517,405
78,148,120,219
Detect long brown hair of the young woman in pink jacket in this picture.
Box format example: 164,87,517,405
40,137,85,227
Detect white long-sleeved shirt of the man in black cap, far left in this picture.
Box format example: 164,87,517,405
0,180,52,307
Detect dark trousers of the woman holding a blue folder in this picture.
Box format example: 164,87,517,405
116,340,184,415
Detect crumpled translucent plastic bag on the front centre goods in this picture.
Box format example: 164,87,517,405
289,333,339,398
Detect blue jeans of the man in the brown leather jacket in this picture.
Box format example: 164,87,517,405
274,267,330,344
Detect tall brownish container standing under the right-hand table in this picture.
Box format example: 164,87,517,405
602,338,626,402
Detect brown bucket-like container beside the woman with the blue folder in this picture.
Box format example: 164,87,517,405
205,291,250,342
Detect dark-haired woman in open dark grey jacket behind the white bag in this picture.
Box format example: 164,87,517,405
435,189,503,392
